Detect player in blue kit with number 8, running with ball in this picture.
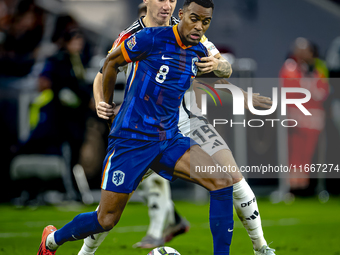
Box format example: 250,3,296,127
38,0,233,255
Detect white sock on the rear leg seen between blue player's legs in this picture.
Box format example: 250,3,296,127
143,174,173,239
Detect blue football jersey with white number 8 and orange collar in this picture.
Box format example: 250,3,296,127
110,25,208,141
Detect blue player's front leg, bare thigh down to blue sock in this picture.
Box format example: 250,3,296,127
174,146,234,255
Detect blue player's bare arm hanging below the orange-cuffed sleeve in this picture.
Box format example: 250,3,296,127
98,47,127,108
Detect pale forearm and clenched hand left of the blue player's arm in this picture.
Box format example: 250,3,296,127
93,72,114,120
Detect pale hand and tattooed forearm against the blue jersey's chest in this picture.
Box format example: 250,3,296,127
196,53,232,78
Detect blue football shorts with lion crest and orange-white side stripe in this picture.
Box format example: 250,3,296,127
101,133,197,193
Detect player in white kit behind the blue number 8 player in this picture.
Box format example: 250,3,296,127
78,0,275,255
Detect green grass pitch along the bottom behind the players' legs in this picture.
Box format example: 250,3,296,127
0,197,340,255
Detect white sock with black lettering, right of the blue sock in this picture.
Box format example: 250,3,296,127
233,178,267,250
